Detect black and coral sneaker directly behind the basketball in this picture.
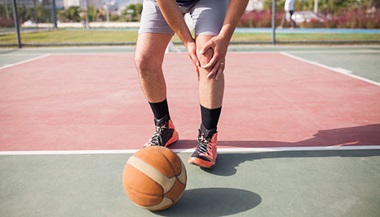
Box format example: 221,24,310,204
144,115,179,147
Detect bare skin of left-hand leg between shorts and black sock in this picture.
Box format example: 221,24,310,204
135,33,172,103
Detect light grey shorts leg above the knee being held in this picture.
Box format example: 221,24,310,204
190,0,229,36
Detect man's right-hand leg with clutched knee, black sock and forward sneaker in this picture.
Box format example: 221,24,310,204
189,35,224,168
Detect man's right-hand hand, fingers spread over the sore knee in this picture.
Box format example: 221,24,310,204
200,36,228,80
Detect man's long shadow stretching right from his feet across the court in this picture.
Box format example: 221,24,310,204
179,124,380,176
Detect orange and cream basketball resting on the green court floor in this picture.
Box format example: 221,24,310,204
123,146,187,211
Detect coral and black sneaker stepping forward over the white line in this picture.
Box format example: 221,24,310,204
188,125,218,169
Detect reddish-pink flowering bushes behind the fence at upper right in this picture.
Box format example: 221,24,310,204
251,0,380,29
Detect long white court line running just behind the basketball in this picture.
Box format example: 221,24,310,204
0,145,380,156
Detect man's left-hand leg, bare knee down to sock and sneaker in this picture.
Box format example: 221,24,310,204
135,33,178,146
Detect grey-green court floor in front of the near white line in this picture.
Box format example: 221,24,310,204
0,150,380,217
